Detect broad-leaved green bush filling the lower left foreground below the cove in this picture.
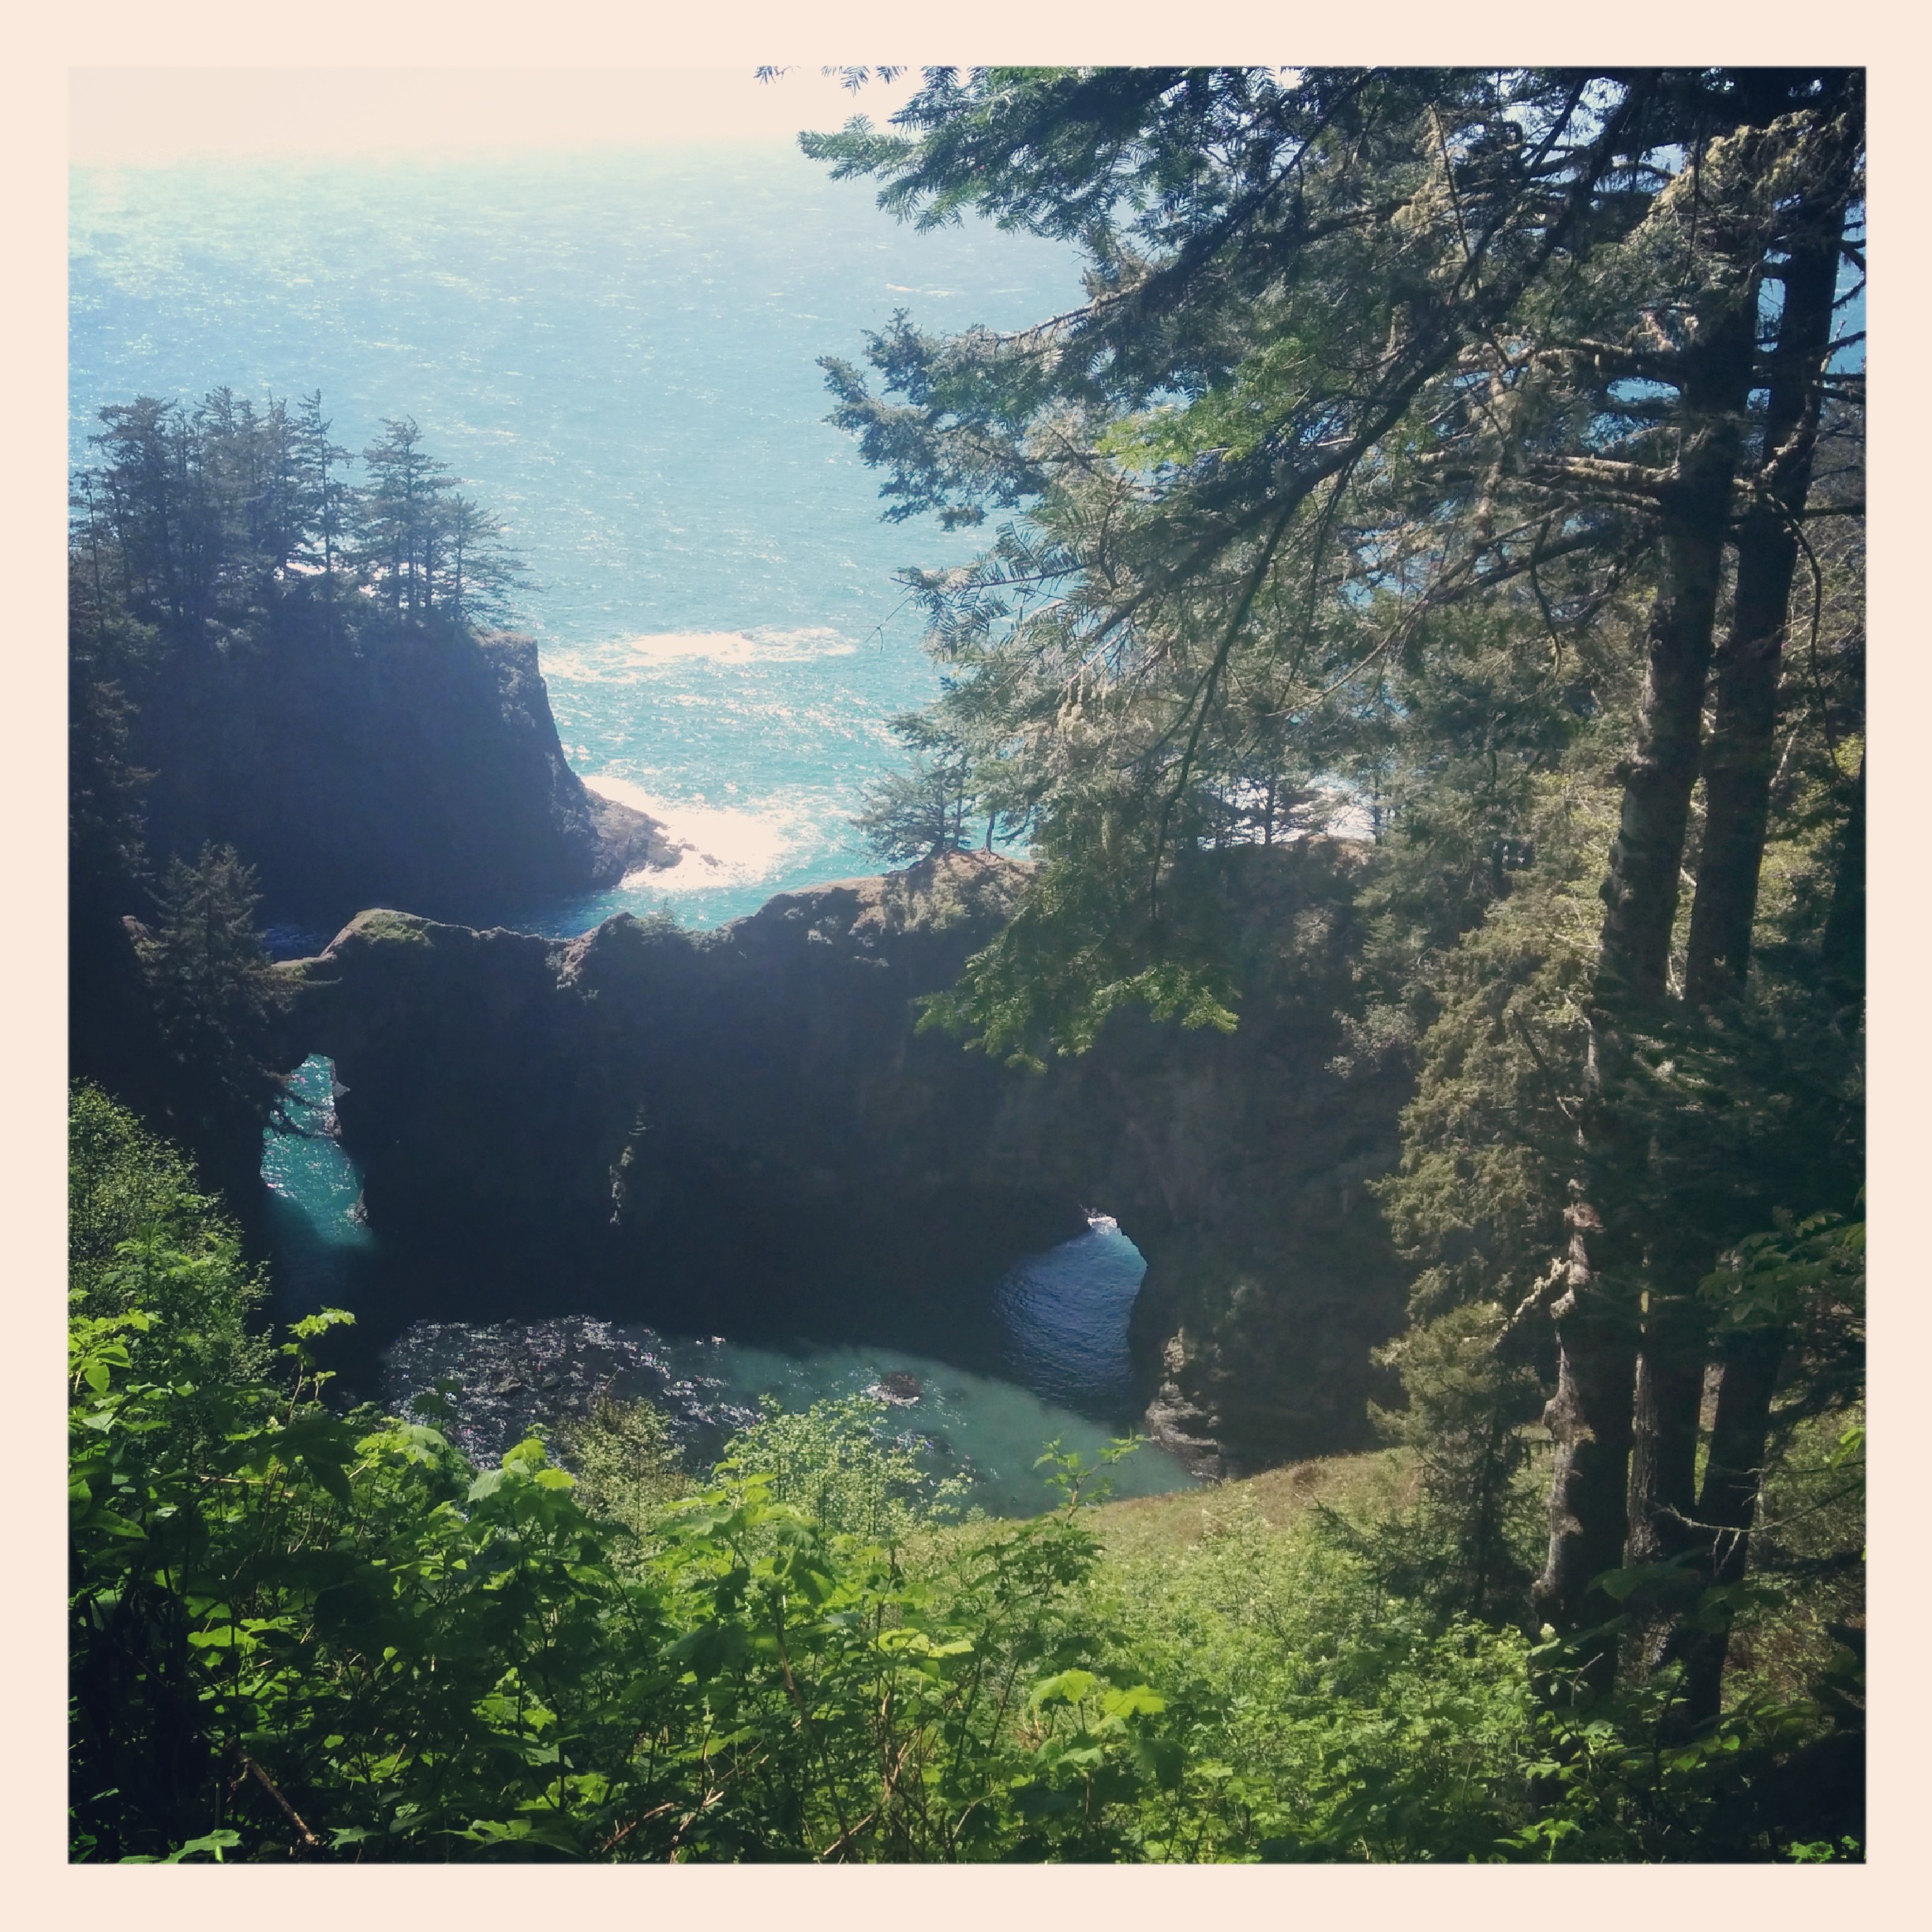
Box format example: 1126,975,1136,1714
72,1310,1167,1859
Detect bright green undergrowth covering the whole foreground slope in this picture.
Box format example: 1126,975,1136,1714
69,1094,1863,1863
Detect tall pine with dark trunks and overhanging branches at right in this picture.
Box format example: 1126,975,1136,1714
806,68,1863,1708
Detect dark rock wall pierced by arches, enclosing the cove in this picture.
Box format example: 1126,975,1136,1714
290,842,1406,1470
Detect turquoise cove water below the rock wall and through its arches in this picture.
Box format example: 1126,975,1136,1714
263,1055,1194,1517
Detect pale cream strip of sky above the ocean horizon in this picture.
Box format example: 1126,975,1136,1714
79,66,938,167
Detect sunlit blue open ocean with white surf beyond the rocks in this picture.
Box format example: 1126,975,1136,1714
69,143,1078,933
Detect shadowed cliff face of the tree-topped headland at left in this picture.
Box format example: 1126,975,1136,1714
133,630,672,926
